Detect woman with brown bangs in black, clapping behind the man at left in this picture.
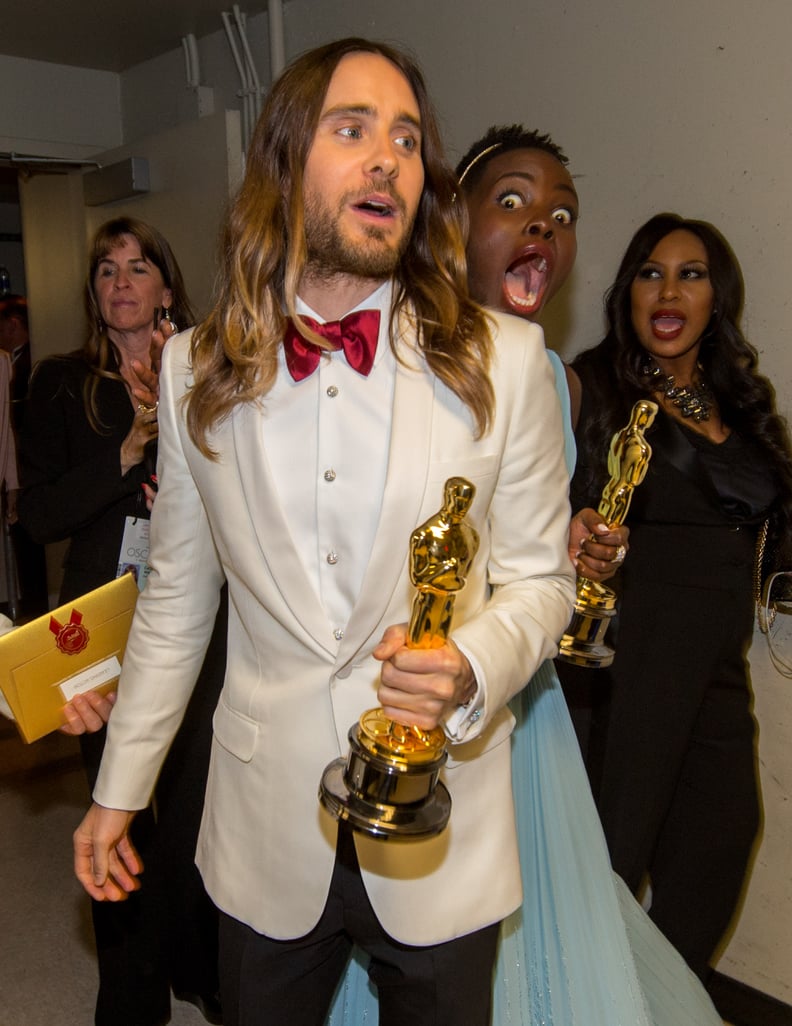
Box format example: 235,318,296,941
18,218,225,1026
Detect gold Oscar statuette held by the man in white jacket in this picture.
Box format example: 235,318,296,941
319,477,478,840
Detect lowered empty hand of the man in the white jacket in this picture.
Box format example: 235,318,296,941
74,802,143,901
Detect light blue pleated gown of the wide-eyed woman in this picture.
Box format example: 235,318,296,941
328,352,721,1026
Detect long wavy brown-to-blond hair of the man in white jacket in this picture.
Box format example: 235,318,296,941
187,38,494,458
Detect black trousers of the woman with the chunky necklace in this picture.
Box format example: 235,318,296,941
598,555,759,979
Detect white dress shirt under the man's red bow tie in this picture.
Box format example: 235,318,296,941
264,281,393,641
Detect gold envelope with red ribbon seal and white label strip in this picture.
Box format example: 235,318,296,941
0,574,138,744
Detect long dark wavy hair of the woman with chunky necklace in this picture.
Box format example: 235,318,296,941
572,213,792,565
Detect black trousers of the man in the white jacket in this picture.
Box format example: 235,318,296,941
220,827,500,1026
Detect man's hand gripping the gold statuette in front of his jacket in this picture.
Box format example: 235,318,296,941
373,624,476,731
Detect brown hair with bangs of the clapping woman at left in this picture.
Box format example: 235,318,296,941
81,218,195,434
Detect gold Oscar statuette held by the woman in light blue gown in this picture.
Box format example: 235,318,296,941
558,399,658,668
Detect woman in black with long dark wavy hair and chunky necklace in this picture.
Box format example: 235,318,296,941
572,214,792,980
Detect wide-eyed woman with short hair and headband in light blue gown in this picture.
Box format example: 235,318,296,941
458,132,720,1026
